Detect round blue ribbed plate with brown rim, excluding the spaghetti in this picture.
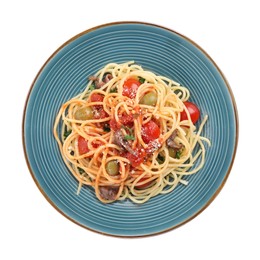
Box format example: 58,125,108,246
23,22,238,237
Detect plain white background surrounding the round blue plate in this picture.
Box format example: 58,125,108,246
0,0,260,260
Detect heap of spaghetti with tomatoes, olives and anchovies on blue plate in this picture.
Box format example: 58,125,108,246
54,61,210,203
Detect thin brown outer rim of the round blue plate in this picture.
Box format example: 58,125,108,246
22,21,239,238
